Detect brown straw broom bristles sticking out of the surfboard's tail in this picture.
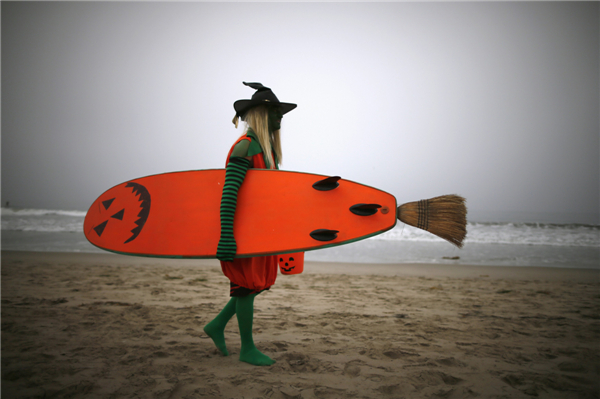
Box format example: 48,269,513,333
398,195,467,248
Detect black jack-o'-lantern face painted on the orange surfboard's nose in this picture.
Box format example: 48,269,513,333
86,182,150,244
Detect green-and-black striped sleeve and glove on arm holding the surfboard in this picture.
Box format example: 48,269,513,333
217,157,250,261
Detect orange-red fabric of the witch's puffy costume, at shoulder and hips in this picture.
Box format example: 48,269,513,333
220,135,278,291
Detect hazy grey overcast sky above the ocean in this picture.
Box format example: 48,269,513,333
1,2,600,224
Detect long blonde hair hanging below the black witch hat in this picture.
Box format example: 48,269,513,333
232,105,282,169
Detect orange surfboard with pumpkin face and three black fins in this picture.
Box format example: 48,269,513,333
84,169,397,258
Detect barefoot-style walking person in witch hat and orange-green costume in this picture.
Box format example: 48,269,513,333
204,82,296,366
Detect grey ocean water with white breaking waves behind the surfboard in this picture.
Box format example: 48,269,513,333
2,208,600,270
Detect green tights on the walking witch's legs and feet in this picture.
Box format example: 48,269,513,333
204,294,275,366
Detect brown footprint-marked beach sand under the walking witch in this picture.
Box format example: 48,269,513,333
2,251,600,399
